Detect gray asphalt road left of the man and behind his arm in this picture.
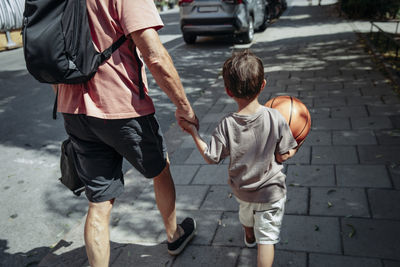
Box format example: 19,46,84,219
0,4,272,266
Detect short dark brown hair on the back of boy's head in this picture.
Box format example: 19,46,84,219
222,50,264,100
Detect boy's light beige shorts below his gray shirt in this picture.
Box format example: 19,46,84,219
236,197,286,244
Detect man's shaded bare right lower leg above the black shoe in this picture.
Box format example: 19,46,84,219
153,161,182,242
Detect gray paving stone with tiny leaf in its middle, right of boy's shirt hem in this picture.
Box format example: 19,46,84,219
310,187,370,217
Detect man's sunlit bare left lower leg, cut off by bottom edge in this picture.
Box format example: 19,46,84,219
85,199,114,267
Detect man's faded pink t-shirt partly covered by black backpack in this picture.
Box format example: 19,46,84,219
58,0,163,119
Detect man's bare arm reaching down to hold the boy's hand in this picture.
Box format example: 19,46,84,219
131,28,198,128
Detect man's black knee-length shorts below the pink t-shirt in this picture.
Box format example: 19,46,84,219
63,114,167,202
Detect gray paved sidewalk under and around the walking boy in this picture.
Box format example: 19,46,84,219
40,0,400,267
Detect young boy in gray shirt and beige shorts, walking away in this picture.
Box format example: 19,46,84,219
180,51,298,266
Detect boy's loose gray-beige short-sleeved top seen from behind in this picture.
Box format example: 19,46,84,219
205,106,297,203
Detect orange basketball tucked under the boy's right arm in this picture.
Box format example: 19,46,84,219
265,95,311,144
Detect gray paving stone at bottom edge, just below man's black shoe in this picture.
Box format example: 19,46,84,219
172,245,240,267
